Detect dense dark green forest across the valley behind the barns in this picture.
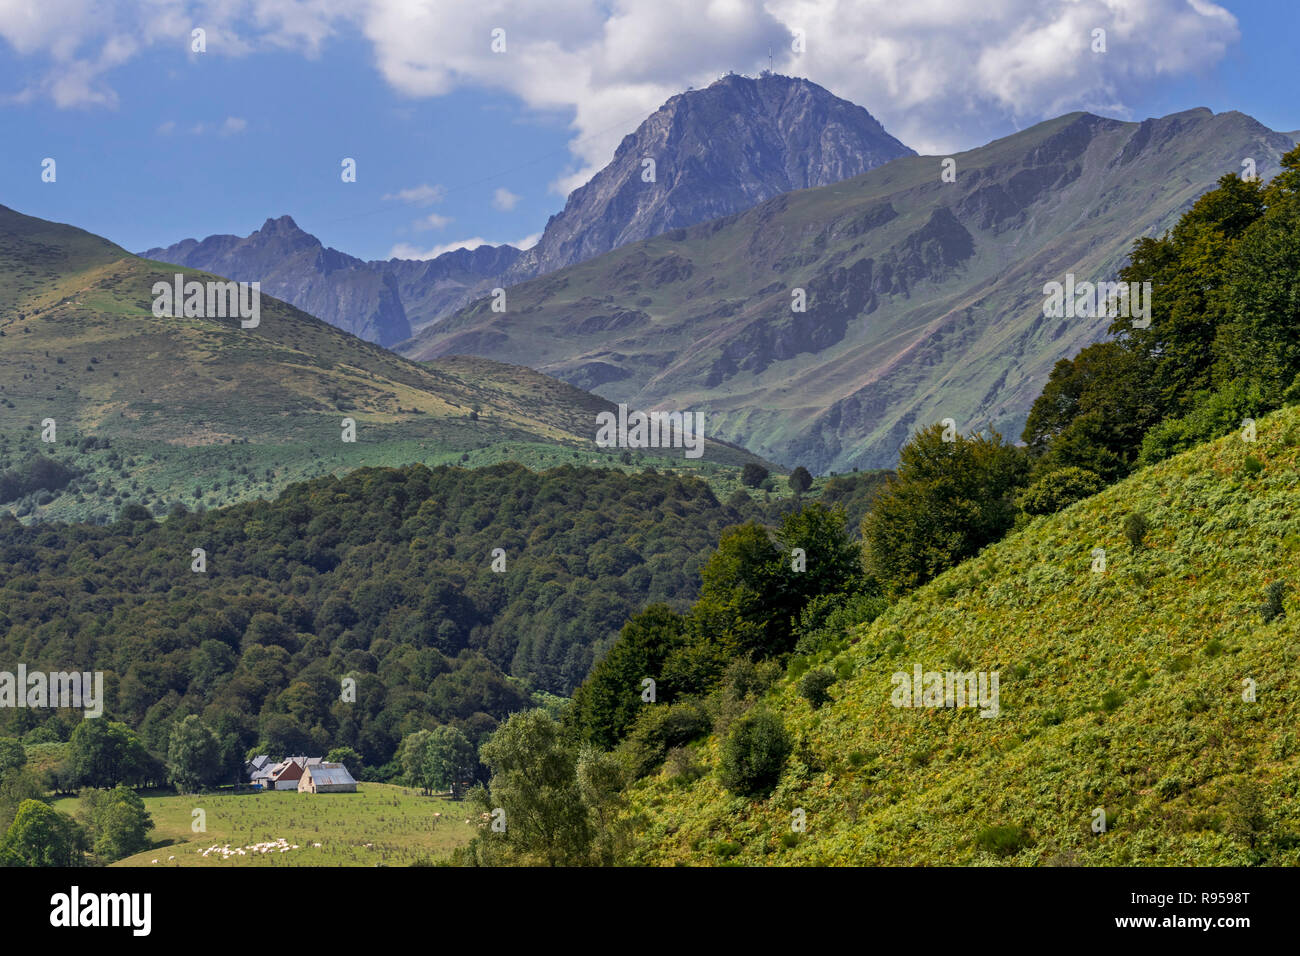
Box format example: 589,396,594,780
0,464,878,790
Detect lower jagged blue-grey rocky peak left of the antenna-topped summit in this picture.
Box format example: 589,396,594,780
140,216,411,346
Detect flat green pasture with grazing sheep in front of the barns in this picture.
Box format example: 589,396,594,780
55,783,476,866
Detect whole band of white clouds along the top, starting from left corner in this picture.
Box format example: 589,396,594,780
0,0,1238,163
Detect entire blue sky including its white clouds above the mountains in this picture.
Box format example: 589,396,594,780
0,0,1300,259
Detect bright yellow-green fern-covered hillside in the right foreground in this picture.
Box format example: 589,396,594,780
621,407,1300,865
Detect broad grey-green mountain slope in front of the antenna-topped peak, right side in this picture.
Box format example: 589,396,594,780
399,109,1291,471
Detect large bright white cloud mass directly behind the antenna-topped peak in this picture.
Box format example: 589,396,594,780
364,0,1238,180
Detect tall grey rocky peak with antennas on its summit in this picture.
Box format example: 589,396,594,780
506,74,915,284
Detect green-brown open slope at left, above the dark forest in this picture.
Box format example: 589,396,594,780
0,207,755,519
